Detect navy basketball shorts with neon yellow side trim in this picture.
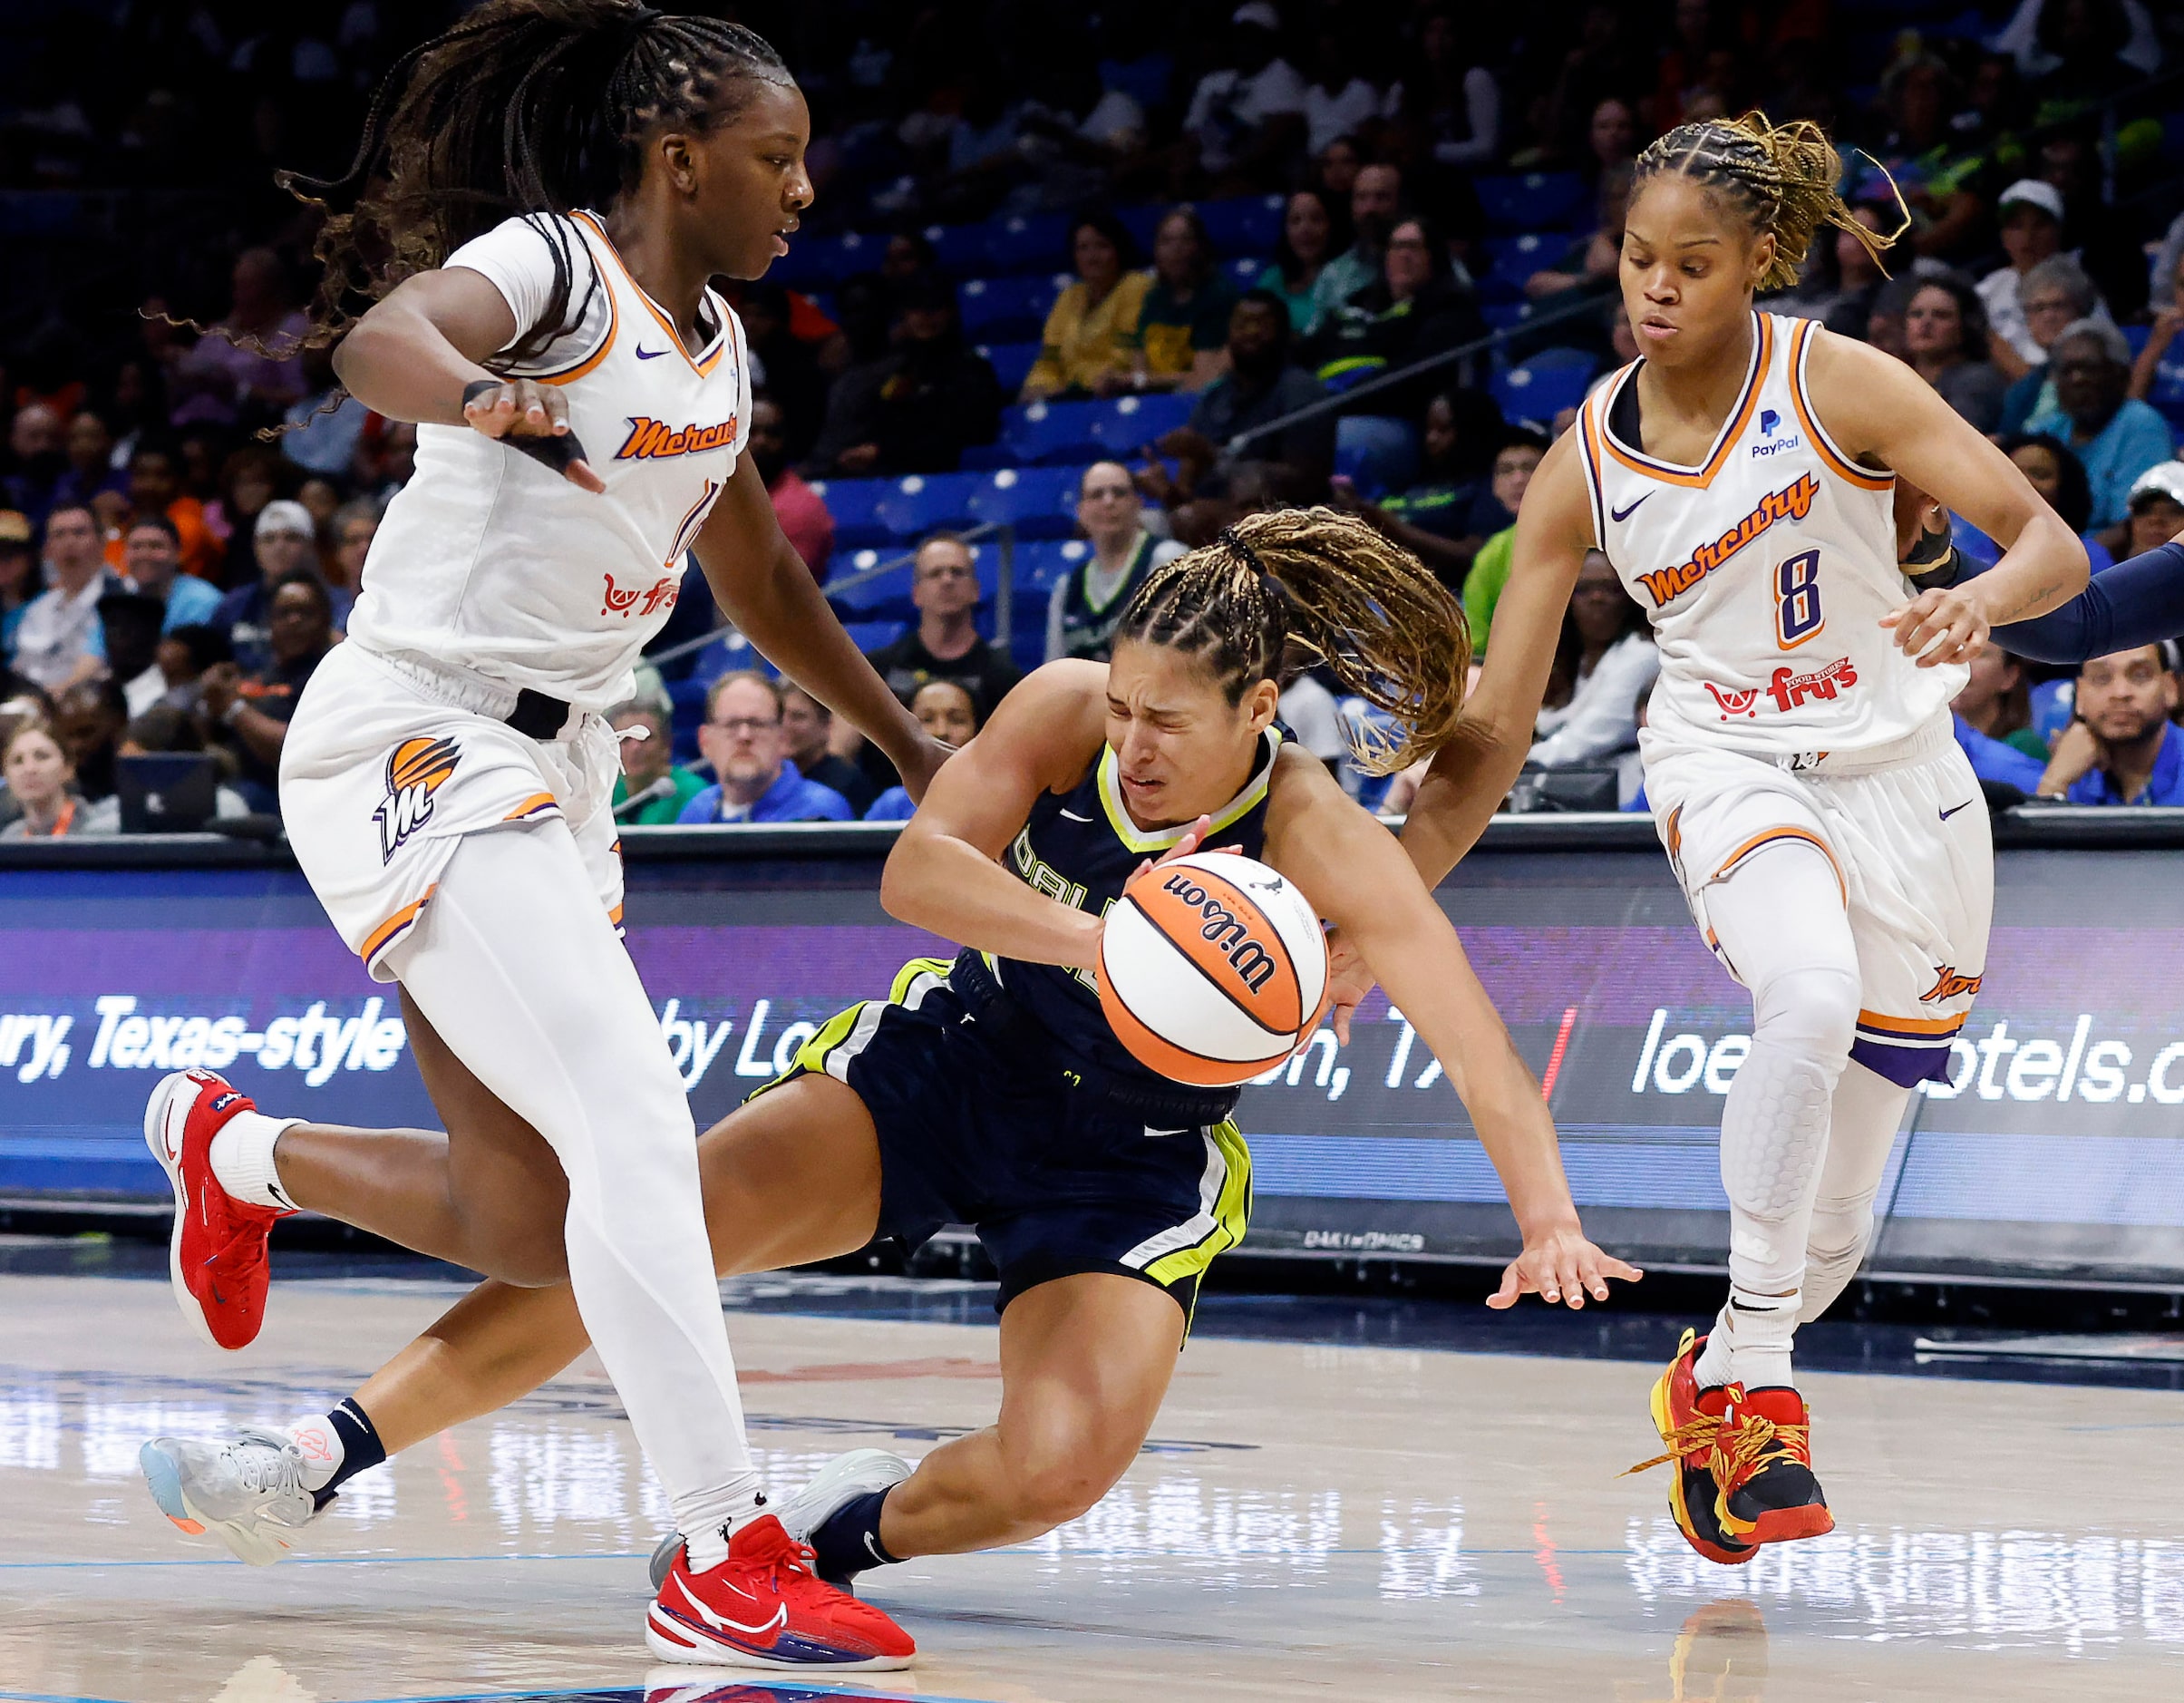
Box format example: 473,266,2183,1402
753,959,1251,1321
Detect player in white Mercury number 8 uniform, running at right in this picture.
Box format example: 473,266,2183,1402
1404,113,2086,1563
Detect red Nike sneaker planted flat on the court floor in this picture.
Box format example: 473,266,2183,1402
645,1513,917,1670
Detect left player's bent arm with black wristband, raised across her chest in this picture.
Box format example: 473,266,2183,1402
335,267,607,491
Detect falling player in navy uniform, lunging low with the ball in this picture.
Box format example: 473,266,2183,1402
136,509,1638,1607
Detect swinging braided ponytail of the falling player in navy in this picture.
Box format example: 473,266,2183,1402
1116,509,1472,775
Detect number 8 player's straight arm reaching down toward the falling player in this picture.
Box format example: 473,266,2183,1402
1367,433,1592,890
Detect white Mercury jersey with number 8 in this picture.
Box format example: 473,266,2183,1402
1579,312,1970,757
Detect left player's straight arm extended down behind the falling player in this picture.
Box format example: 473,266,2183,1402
694,456,948,799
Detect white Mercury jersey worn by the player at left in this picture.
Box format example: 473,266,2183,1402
349,212,752,710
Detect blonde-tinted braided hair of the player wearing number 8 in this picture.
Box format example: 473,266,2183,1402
1632,112,1911,290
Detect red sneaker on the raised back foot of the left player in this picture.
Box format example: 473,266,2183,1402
144,1070,288,1349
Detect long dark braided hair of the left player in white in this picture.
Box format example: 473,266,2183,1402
276,0,792,366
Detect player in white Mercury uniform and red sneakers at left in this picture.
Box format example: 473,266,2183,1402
144,0,944,1668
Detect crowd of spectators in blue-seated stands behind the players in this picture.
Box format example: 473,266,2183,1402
0,0,2184,839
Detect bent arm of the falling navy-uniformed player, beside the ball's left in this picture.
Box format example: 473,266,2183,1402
880,662,1107,969
